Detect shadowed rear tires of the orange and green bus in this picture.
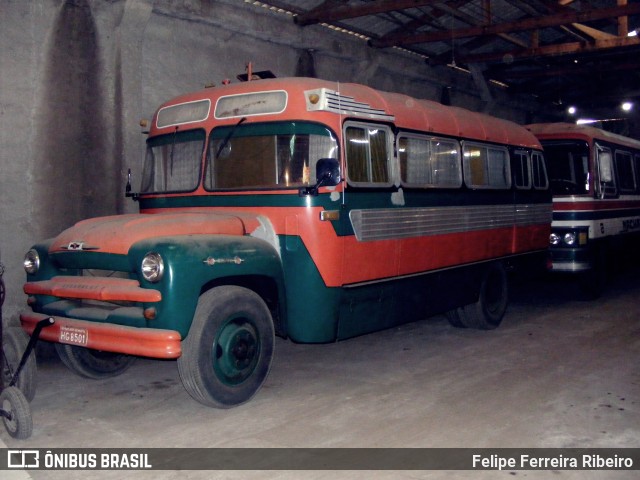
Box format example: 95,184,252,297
447,263,509,330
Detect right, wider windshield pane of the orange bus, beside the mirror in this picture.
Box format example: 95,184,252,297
204,120,338,190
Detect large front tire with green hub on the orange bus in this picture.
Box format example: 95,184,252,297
178,286,275,408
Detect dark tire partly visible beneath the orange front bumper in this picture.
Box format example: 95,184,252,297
55,343,136,380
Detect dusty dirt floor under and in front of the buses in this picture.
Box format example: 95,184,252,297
0,271,640,480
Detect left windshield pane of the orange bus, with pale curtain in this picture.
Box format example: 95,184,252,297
140,129,206,193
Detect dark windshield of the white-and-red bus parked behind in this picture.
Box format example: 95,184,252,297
543,141,589,195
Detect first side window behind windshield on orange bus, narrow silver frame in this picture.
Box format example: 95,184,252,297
344,123,392,186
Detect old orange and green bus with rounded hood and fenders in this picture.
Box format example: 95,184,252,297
21,78,552,408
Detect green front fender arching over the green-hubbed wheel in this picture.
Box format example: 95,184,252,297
129,235,286,338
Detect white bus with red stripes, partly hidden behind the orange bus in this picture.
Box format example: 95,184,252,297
527,123,640,297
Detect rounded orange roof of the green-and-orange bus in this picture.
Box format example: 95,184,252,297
154,77,541,149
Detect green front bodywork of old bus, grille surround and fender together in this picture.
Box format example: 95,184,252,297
27,235,286,337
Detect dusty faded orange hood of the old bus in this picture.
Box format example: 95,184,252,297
49,212,250,255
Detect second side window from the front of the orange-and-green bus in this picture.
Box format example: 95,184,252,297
398,135,462,188
